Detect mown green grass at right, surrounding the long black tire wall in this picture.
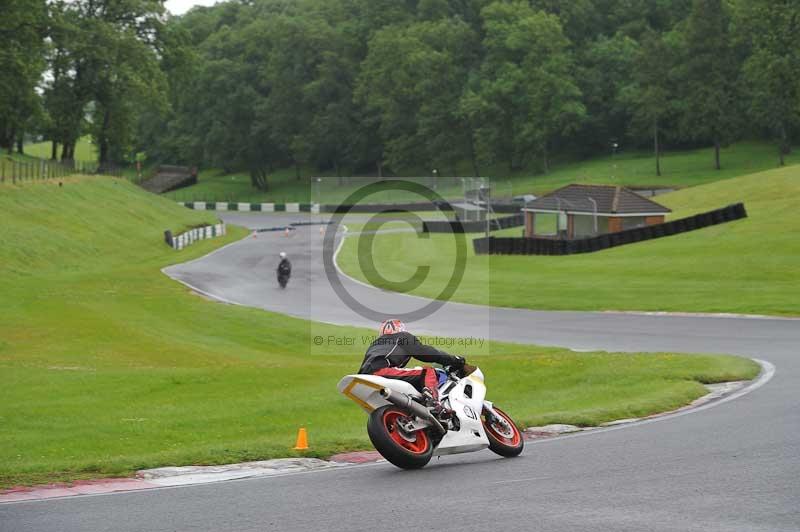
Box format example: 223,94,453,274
339,166,800,315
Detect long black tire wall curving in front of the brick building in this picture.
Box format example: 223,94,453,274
472,203,747,255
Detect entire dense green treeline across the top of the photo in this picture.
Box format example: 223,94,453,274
0,0,800,188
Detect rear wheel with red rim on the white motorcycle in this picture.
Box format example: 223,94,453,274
367,405,433,469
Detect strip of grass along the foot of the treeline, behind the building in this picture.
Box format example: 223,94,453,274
162,142,800,203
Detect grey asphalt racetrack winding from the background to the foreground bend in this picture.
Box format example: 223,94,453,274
0,213,800,532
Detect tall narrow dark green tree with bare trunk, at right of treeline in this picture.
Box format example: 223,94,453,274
681,0,740,170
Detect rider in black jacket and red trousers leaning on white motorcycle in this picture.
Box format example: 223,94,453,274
358,320,466,419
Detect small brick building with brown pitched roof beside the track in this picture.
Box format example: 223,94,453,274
522,185,672,239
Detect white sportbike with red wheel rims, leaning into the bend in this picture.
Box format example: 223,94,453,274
339,365,524,469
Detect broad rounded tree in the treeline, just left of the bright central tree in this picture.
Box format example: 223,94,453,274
356,18,478,172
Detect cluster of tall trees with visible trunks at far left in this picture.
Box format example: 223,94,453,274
0,0,168,163
